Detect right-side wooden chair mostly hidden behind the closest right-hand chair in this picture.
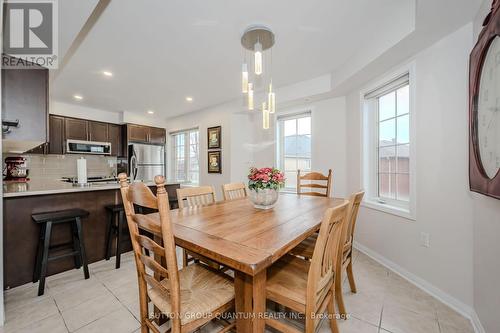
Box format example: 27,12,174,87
290,191,365,315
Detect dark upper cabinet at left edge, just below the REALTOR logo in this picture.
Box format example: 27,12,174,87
2,58,49,151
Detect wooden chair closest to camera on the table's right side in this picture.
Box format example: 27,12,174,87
266,200,349,333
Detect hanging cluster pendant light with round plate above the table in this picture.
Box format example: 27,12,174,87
241,26,276,129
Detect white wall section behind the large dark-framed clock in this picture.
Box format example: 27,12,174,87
472,0,500,332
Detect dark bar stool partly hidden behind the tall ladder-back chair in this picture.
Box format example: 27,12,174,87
105,204,129,269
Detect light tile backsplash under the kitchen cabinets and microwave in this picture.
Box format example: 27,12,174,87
3,154,117,180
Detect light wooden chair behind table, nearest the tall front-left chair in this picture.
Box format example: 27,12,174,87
177,186,221,269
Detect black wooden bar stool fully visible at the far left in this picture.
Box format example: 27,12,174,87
31,209,90,296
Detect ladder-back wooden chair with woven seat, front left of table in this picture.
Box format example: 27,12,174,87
118,173,234,333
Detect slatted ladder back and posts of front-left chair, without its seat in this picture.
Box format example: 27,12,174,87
118,173,181,332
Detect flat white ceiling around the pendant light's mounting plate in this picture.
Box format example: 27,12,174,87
51,0,418,117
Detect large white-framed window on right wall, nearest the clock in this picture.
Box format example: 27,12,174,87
362,73,414,217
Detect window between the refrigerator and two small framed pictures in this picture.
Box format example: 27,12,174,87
171,129,200,184
